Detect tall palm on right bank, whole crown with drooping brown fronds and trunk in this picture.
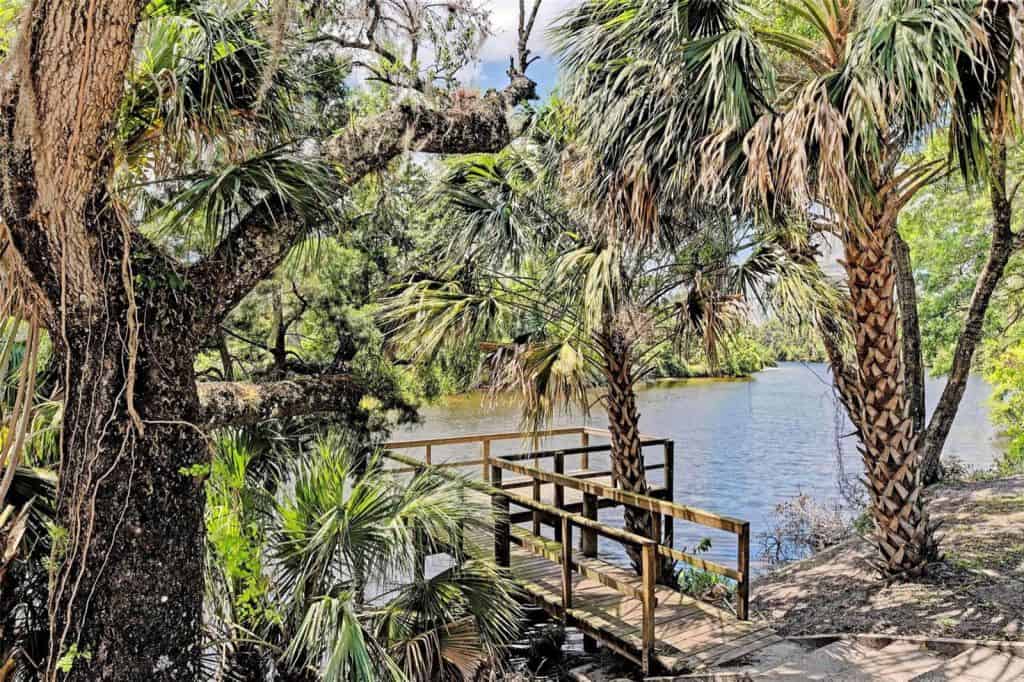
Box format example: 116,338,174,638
557,0,1012,577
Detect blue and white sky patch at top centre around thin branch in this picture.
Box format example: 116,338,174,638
470,0,579,99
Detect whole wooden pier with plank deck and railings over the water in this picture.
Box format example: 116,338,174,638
386,427,780,674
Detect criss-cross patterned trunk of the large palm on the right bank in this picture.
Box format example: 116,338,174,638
845,213,937,578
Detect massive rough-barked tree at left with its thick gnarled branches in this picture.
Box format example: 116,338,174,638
0,0,532,681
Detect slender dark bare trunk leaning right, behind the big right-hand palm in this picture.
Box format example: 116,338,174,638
921,126,1018,484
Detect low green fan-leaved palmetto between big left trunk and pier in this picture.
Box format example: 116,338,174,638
269,440,519,681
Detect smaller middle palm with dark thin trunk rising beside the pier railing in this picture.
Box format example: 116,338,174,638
382,112,827,563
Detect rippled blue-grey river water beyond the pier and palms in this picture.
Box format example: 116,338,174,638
394,363,999,568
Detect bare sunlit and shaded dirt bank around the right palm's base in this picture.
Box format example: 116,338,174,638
752,476,1024,640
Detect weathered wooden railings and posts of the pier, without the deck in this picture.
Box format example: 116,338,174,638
387,427,750,671
